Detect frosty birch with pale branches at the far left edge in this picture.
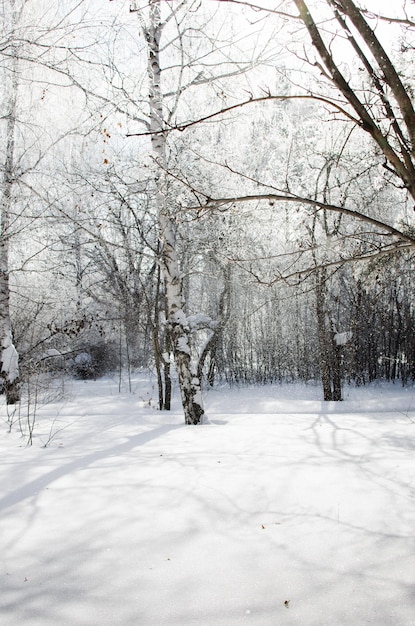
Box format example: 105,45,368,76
0,0,120,390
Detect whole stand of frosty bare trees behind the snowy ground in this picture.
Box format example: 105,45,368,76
0,0,415,424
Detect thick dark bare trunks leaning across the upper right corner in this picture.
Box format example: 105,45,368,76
294,0,415,199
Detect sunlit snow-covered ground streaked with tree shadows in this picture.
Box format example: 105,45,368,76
0,378,415,626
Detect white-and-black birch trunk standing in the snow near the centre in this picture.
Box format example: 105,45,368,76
145,0,204,424
